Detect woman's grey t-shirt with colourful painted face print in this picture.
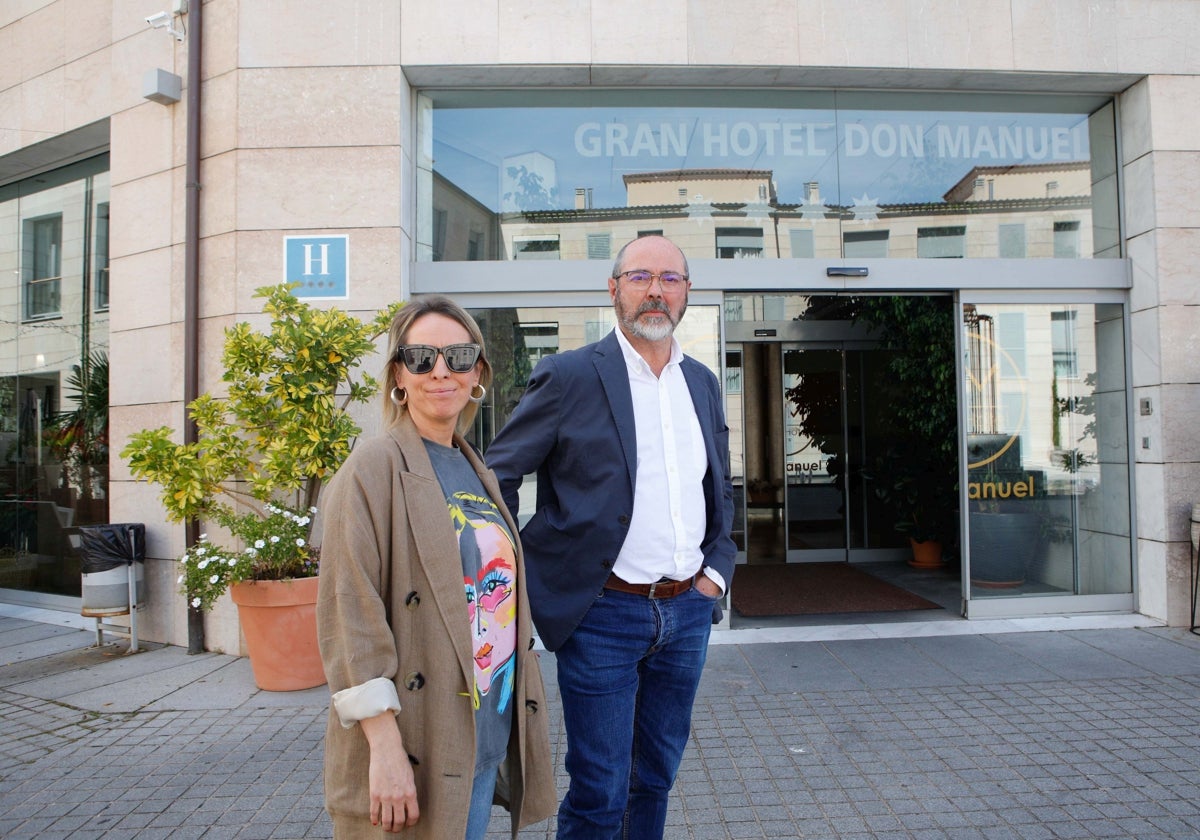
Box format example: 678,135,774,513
425,440,517,770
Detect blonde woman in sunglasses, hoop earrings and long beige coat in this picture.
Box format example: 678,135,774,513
317,296,556,840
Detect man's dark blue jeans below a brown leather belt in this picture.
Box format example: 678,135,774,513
556,587,715,840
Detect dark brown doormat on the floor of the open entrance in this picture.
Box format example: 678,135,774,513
731,563,941,616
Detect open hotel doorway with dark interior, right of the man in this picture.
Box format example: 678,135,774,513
725,295,961,624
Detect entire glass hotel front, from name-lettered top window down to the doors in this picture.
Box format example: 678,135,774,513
424,90,1133,616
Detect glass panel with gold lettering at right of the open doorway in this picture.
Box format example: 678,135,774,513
964,304,1133,599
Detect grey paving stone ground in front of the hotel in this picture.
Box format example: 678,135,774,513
0,616,1200,840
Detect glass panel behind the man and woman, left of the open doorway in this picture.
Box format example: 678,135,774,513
467,305,721,523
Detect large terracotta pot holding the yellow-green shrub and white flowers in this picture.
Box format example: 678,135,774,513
229,577,325,691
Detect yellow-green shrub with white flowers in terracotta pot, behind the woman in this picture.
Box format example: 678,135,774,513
121,284,402,691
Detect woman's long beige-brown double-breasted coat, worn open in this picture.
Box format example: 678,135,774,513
317,416,557,840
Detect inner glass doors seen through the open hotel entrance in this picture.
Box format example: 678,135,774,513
725,341,901,563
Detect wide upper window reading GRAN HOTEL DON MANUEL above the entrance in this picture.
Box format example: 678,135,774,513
416,90,1120,260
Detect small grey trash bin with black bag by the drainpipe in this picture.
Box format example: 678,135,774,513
79,522,146,653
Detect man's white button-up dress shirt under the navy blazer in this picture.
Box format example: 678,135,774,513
613,329,725,592
